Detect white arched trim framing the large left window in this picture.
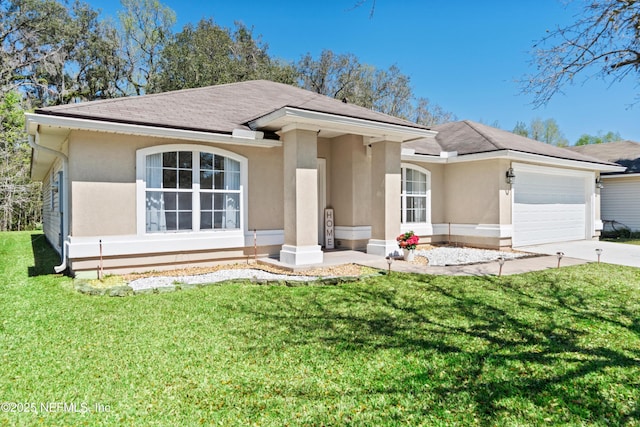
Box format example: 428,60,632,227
136,144,249,247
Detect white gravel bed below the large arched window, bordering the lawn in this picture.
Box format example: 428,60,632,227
129,268,317,291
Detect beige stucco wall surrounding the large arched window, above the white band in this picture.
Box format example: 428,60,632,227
69,131,284,236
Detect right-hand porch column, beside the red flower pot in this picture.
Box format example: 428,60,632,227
367,141,402,256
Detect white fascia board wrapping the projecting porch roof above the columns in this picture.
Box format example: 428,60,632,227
249,107,437,141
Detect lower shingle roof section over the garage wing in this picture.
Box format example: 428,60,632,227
403,120,612,165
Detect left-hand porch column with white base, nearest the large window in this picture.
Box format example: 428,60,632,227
280,125,323,265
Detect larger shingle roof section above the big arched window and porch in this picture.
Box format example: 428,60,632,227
36,80,428,133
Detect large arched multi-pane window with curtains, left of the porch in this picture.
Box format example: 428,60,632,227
139,147,243,233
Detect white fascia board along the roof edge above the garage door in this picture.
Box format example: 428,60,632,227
402,150,625,172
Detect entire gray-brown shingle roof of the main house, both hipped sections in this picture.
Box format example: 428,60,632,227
36,80,611,168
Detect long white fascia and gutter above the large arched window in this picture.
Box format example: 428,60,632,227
25,113,282,148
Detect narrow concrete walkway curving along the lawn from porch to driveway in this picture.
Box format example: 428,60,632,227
260,251,587,276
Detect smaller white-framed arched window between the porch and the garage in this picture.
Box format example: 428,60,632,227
401,165,431,224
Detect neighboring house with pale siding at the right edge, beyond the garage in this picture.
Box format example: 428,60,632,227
570,141,640,231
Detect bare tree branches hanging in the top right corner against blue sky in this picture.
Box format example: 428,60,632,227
522,0,640,106
